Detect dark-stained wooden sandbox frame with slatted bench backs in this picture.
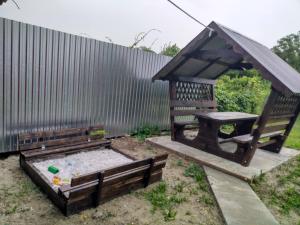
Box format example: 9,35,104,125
18,126,168,216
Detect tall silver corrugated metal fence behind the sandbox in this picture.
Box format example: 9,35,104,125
0,18,170,152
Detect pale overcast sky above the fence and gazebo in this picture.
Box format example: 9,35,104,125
0,0,300,51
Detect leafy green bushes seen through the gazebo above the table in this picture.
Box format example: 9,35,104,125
216,70,270,113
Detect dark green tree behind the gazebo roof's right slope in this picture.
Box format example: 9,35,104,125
272,31,300,72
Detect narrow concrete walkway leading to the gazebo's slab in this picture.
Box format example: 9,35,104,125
204,166,279,225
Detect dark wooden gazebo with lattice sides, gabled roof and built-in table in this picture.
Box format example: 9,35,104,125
152,22,300,166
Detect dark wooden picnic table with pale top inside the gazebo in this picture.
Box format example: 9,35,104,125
189,112,258,161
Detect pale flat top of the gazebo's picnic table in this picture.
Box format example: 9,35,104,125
194,112,258,122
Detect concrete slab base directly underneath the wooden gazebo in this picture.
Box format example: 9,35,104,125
147,136,300,181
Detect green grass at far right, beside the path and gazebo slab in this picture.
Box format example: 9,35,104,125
252,118,300,225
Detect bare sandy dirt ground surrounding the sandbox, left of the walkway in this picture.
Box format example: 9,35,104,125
0,137,223,225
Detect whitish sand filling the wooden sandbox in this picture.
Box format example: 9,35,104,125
33,149,133,190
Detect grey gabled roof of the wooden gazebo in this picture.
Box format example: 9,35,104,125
152,22,300,94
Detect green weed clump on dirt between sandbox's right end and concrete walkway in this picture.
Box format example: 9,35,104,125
145,182,186,221
